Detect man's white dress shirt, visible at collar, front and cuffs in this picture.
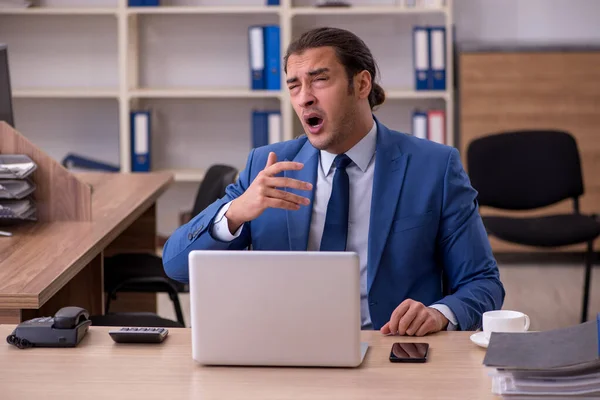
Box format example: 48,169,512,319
212,121,458,330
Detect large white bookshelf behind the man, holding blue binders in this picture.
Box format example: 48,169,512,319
0,0,454,234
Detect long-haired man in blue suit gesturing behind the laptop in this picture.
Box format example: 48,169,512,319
163,28,504,336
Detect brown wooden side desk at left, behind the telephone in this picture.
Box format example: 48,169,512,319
0,173,173,323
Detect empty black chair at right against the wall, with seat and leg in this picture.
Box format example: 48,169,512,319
467,130,600,322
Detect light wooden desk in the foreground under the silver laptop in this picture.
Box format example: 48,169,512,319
0,325,496,400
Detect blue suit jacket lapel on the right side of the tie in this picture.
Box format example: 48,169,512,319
367,123,408,291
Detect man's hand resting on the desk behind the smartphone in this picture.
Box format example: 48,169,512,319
381,299,448,336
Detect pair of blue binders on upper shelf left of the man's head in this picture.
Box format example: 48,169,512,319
248,25,281,90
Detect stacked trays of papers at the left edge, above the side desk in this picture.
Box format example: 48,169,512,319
0,154,37,224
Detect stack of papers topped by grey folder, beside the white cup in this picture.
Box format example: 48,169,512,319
483,314,600,400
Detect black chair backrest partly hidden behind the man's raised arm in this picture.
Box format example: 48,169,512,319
192,164,238,217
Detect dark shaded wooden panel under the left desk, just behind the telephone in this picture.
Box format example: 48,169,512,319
14,253,104,321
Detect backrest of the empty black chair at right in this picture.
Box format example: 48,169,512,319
467,130,584,210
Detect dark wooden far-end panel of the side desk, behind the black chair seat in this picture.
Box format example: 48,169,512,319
104,204,157,313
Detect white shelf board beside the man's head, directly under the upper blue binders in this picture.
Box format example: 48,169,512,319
129,89,281,99
